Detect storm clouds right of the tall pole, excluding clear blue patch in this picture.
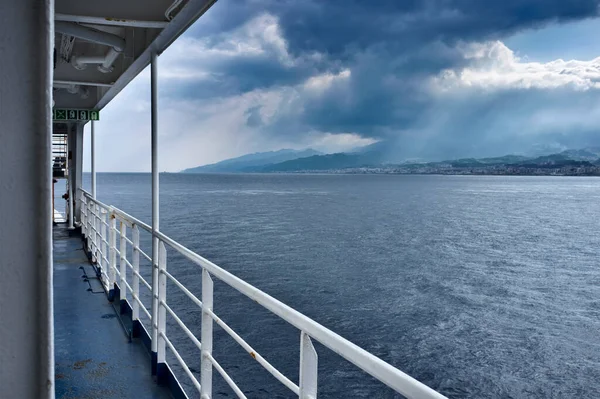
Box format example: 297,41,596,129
86,0,600,170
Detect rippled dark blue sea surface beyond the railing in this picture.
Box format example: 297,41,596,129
78,174,600,399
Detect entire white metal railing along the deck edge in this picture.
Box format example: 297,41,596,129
80,190,444,399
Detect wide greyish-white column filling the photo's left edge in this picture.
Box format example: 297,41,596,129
0,0,55,399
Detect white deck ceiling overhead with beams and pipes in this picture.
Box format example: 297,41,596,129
53,0,216,110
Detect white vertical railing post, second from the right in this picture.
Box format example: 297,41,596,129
200,269,213,399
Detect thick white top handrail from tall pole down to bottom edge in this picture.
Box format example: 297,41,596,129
156,232,445,399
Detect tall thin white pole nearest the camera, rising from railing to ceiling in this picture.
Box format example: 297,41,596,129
150,53,159,374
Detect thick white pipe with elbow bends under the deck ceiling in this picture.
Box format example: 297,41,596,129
54,21,125,73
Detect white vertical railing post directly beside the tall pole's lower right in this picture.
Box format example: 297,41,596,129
156,241,167,384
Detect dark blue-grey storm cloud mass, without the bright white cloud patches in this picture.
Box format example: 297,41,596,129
166,0,599,158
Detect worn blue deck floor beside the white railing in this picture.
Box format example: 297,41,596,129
54,224,172,399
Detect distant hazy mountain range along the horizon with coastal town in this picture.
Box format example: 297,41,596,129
183,142,600,173
